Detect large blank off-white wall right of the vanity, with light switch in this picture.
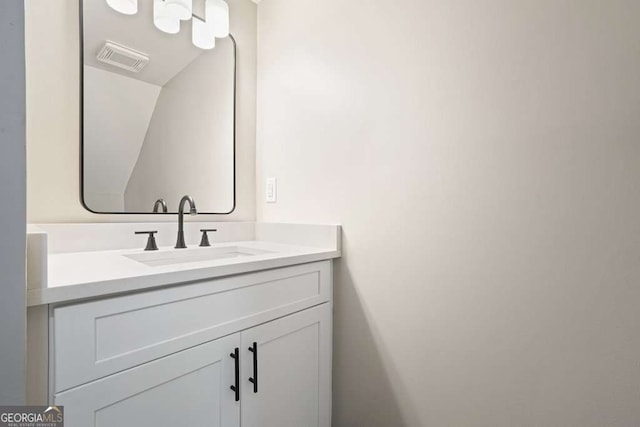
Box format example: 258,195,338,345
257,0,640,427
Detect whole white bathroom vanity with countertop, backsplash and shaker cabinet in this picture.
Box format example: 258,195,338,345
28,223,340,427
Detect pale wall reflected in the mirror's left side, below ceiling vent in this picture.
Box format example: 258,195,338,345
84,65,162,212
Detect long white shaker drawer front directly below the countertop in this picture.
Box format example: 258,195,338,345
53,261,331,392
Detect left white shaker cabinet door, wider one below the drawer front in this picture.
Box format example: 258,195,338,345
54,334,240,427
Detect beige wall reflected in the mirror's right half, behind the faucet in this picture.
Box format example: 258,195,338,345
124,39,234,212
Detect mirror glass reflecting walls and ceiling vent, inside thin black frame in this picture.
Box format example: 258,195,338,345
81,0,236,214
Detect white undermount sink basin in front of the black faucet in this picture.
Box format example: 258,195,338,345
124,246,271,267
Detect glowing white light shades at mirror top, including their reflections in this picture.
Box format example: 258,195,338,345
106,0,229,50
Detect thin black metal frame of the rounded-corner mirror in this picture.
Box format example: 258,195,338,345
78,0,238,215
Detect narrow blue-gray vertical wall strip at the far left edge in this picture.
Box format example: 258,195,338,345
0,0,26,405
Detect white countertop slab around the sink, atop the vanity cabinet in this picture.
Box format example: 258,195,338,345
27,241,340,306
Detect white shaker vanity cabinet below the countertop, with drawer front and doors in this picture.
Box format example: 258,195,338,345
35,261,332,427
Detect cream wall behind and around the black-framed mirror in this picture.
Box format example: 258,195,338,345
25,0,256,223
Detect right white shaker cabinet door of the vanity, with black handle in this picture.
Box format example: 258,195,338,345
241,304,331,427
